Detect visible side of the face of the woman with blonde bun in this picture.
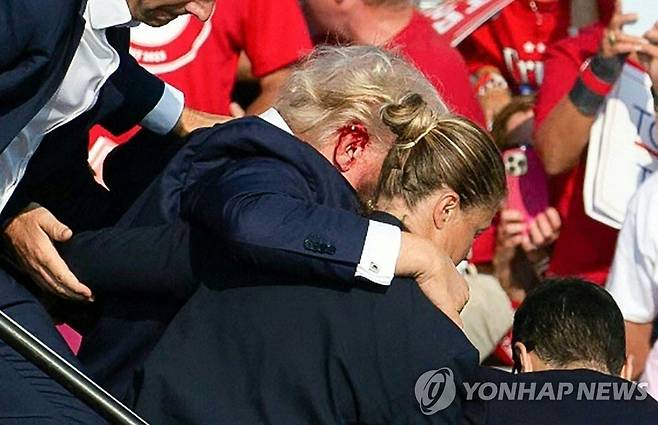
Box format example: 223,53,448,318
430,203,496,265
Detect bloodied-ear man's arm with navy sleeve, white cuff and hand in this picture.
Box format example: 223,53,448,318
181,159,468,322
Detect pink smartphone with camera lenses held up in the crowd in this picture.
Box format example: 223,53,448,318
503,145,549,229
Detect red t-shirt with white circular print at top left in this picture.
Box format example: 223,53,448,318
92,0,312,146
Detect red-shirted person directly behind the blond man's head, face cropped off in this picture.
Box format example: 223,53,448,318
302,0,484,125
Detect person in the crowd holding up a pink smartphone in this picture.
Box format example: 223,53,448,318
462,97,561,366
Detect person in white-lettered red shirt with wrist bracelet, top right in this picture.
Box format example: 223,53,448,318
458,0,613,125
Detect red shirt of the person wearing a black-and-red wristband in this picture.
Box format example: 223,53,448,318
535,25,617,285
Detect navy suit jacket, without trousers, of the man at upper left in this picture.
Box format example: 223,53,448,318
0,0,164,230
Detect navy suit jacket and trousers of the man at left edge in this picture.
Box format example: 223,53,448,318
0,4,172,418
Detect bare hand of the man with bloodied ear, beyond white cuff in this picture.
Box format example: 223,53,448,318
395,232,469,327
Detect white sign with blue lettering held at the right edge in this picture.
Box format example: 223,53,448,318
583,63,658,229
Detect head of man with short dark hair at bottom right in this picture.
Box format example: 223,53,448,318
512,278,626,376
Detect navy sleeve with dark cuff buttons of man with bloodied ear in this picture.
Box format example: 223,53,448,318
183,159,368,284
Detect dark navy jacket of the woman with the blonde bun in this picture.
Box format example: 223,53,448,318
135,210,478,425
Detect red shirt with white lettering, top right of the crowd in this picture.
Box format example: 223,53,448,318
459,0,571,93
